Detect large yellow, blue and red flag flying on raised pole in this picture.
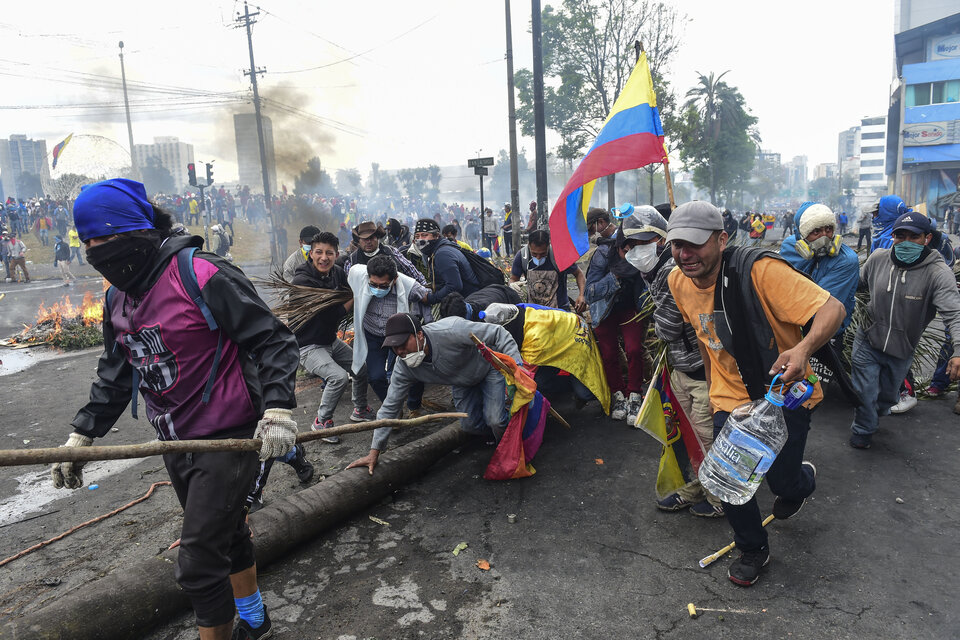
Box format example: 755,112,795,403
550,52,667,270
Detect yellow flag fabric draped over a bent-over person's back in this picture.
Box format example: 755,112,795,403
520,307,610,414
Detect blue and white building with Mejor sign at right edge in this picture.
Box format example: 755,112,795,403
886,0,960,220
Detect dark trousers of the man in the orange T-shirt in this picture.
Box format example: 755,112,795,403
713,407,817,551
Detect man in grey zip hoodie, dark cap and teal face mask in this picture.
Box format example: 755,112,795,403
850,211,960,449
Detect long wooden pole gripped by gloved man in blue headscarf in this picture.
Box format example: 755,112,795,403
0,413,467,467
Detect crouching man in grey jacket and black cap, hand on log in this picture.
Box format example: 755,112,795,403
347,313,523,474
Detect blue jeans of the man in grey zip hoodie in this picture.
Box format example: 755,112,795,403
850,331,913,436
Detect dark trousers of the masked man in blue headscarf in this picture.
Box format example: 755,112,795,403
163,444,259,627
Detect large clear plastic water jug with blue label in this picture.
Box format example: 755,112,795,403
697,374,787,504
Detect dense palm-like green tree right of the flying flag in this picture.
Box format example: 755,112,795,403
679,72,760,203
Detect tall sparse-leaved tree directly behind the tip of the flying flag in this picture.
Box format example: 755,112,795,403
514,0,686,188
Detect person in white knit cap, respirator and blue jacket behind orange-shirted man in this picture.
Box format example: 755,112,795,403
780,202,860,333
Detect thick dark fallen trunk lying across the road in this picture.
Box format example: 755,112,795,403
0,424,469,640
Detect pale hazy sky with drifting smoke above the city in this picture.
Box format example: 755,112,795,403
0,0,893,183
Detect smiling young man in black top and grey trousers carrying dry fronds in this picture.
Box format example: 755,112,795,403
293,231,373,444
